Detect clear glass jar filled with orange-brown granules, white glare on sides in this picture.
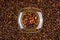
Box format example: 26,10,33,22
18,7,43,33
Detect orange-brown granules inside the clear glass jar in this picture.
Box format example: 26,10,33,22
22,12,39,28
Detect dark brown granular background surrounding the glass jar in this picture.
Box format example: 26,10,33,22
0,0,60,40
